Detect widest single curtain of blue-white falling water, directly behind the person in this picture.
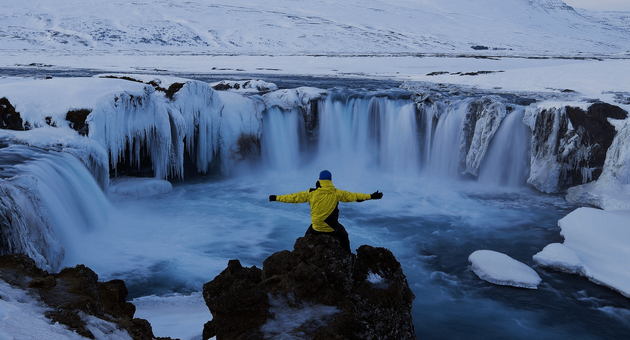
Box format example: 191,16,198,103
317,97,420,174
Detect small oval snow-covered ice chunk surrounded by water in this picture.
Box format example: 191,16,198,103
468,250,542,289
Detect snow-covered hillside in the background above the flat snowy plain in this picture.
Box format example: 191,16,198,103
0,0,630,55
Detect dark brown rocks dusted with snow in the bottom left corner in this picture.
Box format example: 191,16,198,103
0,254,168,340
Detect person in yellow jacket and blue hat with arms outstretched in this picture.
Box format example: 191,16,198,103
269,170,383,252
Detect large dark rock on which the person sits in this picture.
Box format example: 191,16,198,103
203,235,416,340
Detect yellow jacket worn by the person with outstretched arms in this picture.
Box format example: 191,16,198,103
276,180,372,232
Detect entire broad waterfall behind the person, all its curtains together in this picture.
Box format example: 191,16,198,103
262,95,531,187
